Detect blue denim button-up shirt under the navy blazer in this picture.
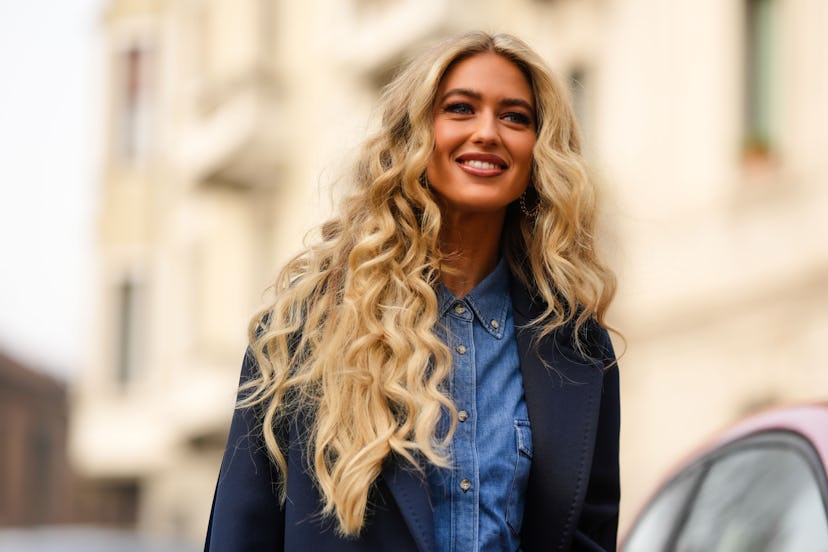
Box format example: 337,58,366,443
428,260,532,552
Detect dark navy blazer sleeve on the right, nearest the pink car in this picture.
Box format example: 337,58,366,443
572,328,621,551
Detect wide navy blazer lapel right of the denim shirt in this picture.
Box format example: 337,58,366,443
512,284,603,550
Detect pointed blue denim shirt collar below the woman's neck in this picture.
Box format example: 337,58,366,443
437,258,512,339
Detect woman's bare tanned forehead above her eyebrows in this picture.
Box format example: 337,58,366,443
437,52,535,105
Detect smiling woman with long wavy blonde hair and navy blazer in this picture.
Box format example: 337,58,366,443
206,33,619,551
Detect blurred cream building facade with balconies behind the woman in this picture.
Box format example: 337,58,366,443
71,0,828,541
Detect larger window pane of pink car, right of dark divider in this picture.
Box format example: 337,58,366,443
675,443,828,552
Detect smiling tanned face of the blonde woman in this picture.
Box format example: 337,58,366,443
426,52,536,214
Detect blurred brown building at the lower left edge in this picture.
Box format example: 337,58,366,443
0,352,138,528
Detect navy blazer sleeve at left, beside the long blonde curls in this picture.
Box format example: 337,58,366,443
204,349,284,552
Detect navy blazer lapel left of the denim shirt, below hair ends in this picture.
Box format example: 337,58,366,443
382,458,436,552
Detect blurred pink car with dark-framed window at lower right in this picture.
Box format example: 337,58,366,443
621,403,828,552
